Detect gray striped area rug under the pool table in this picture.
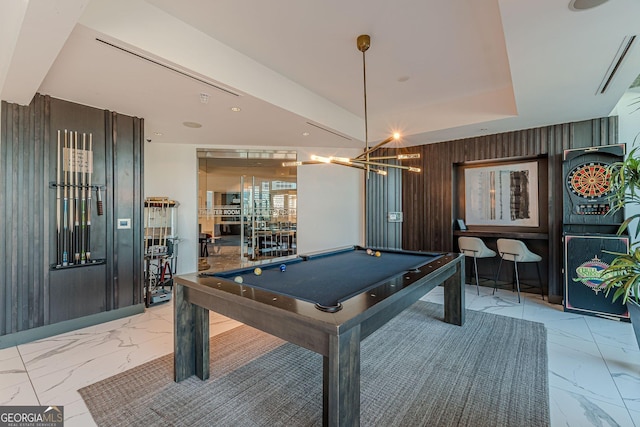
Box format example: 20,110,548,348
79,301,549,427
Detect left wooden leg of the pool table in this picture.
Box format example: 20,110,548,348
173,283,209,382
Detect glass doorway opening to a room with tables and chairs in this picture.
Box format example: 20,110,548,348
197,149,298,271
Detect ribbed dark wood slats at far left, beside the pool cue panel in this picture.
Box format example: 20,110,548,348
0,94,49,334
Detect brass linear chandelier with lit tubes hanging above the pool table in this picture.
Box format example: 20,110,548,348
282,34,421,175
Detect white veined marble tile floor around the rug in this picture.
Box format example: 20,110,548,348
0,286,640,427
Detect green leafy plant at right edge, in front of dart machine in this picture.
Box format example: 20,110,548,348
602,145,640,346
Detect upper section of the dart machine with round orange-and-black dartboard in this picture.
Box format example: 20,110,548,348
562,144,625,226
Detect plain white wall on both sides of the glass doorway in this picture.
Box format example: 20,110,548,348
144,142,364,274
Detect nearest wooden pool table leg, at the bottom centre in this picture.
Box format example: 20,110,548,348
322,325,360,426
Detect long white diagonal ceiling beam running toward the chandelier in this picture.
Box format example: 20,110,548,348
80,0,364,139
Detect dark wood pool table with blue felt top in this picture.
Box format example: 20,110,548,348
174,246,465,426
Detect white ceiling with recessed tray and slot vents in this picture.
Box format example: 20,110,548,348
0,0,640,154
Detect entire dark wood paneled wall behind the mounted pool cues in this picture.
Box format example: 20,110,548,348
0,94,144,336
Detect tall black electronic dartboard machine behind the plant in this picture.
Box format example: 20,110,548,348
562,144,629,320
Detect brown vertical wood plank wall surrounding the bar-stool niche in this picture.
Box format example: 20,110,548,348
392,117,618,302
